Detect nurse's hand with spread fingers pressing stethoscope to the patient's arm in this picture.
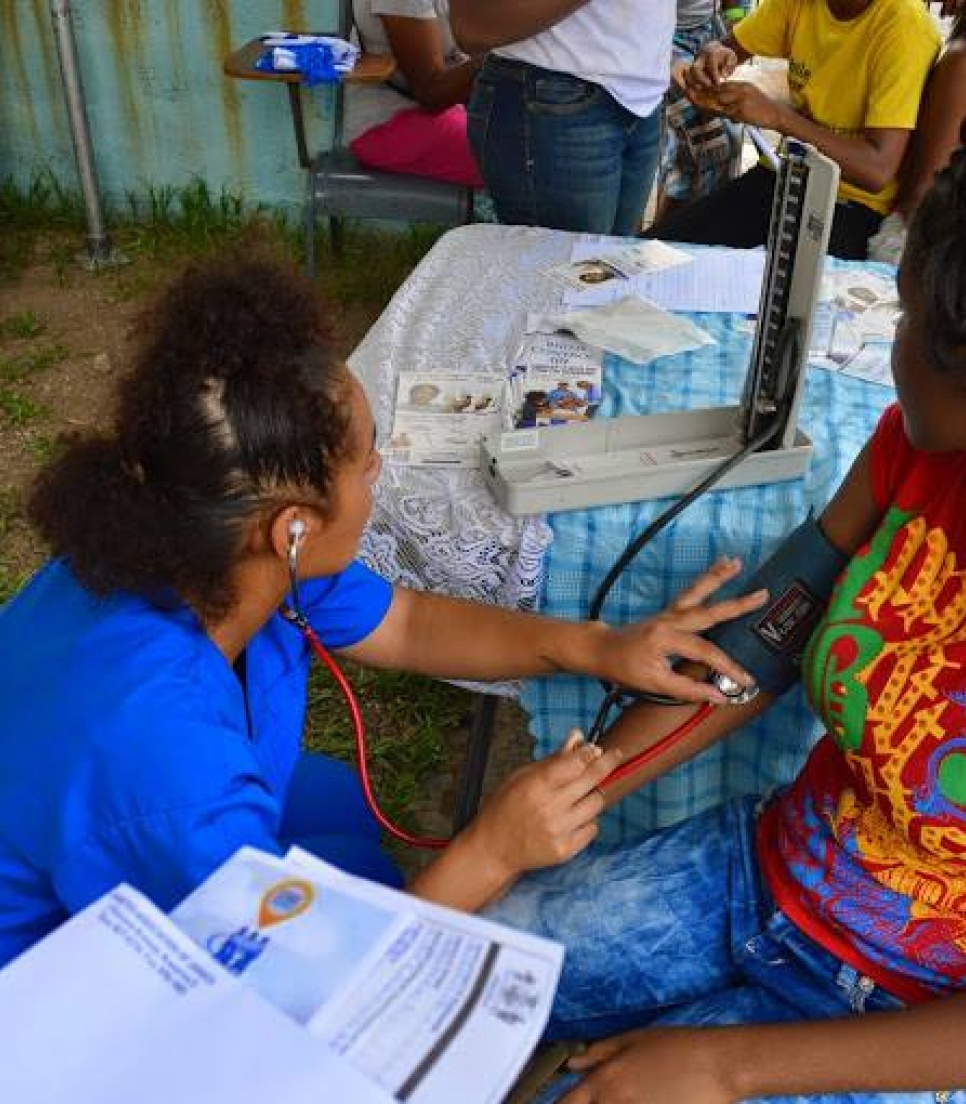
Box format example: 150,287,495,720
592,559,767,704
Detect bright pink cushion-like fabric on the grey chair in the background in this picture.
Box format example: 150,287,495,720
349,104,484,188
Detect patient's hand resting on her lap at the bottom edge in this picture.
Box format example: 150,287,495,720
559,1028,740,1104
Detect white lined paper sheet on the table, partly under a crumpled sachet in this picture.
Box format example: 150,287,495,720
563,242,765,315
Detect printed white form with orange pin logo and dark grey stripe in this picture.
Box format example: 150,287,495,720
173,848,563,1104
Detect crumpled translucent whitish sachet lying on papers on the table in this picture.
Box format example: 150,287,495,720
550,296,715,364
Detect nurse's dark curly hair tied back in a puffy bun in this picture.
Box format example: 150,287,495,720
29,257,351,619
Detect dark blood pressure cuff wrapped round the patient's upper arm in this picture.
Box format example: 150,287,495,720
705,514,849,694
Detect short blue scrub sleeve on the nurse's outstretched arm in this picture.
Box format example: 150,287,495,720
299,560,392,648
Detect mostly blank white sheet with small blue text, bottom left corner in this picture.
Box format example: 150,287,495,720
0,887,392,1104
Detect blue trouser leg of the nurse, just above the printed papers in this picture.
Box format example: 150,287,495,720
278,753,403,887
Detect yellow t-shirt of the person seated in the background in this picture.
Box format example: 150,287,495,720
732,0,941,214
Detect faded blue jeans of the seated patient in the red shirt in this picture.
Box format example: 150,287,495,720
487,798,966,1104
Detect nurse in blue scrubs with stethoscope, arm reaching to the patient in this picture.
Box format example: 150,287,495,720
0,259,749,965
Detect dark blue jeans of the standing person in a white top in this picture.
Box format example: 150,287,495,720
468,55,660,235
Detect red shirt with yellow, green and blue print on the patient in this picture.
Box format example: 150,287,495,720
758,406,966,1002
